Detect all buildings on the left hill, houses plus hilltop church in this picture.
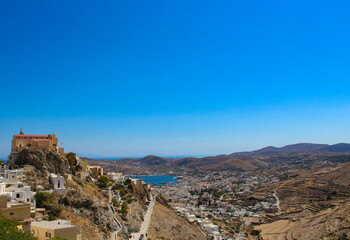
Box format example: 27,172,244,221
0,129,156,240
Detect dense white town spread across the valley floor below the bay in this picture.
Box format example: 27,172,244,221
158,172,276,239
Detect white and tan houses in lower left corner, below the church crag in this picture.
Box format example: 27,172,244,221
0,164,78,240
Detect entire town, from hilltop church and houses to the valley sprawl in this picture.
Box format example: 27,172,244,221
0,129,286,240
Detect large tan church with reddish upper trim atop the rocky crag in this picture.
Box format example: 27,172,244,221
9,129,65,161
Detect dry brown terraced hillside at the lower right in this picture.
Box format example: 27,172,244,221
254,163,350,240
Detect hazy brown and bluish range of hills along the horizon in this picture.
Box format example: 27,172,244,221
84,143,350,171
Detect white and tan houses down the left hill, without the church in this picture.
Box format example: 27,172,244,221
0,155,131,240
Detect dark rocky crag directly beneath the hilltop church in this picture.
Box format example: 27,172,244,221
14,149,71,175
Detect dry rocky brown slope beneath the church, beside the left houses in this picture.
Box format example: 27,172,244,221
16,150,149,240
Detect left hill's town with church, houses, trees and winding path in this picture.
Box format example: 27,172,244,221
0,129,153,240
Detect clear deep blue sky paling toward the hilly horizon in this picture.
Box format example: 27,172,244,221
0,0,350,156
